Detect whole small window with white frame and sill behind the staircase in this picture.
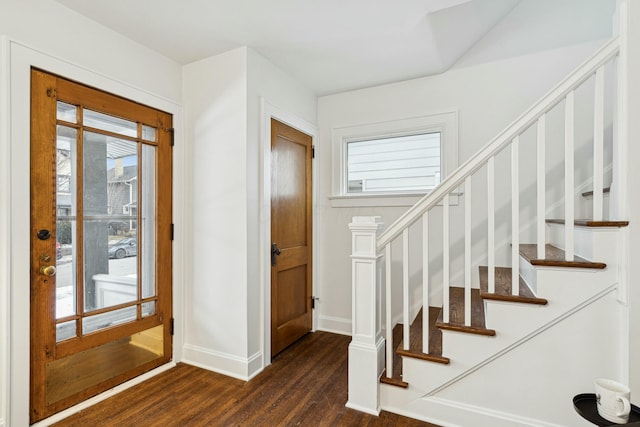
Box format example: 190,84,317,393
329,111,458,207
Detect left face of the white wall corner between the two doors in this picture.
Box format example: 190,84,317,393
183,48,248,376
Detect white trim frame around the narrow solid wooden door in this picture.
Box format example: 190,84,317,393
256,97,319,373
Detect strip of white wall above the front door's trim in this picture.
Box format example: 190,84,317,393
0,0,182,100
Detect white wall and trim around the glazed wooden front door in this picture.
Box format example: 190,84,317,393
0,0,184,426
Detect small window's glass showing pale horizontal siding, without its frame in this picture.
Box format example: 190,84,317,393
346,132,442,194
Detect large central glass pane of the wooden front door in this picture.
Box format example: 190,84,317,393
82,131,139,316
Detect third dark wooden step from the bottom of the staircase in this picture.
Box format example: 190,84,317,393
436,287,496,336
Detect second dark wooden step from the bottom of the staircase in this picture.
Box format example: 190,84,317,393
396,307,450,364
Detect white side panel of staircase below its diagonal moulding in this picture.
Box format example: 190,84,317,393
381,285,622,427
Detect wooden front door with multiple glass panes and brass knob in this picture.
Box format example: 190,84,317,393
29,70,172,422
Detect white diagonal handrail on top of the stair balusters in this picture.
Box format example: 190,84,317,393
377,37,620,251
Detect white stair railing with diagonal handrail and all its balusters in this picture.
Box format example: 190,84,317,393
349,38,619,389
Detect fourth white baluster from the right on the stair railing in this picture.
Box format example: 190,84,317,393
511,136,520,295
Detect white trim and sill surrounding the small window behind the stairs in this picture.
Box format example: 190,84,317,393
329,110,458,207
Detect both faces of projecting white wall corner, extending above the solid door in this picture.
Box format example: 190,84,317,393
184,48,315,379
